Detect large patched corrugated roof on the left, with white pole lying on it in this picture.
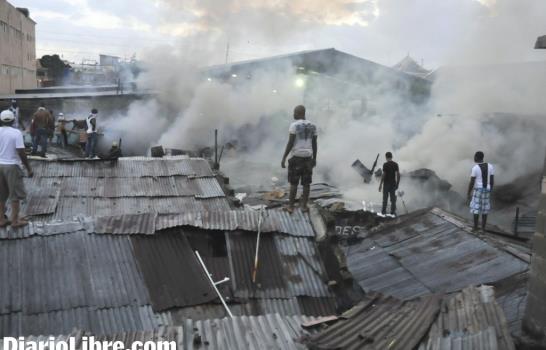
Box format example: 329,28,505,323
0,157,336,336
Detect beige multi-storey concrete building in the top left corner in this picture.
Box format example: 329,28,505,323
0,0,36,94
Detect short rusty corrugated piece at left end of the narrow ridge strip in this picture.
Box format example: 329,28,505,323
94,213,157,235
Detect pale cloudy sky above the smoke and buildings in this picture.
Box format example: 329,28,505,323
9,0,546,68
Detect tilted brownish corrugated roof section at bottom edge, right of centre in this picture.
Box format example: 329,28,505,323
306,294,441,350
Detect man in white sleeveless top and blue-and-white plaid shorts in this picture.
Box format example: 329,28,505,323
468,151,495,231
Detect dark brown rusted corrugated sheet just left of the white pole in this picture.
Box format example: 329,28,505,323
131,232,217,311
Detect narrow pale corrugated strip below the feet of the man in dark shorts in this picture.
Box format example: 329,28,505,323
156,210,315,237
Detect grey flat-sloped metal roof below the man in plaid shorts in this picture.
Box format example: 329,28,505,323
346,212,528,299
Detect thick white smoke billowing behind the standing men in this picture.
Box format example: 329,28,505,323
107,0,546,220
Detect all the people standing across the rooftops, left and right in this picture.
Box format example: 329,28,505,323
0,104,495,230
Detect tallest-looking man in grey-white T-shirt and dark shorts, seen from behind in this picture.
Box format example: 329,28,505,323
281,105,317,213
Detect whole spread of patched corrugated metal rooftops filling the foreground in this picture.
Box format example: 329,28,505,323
0,156,530,349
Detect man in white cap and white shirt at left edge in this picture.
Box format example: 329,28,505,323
0,110,34,228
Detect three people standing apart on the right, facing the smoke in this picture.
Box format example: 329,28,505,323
281,105,495,231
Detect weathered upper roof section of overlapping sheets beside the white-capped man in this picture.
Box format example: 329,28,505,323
16,157,231,223
